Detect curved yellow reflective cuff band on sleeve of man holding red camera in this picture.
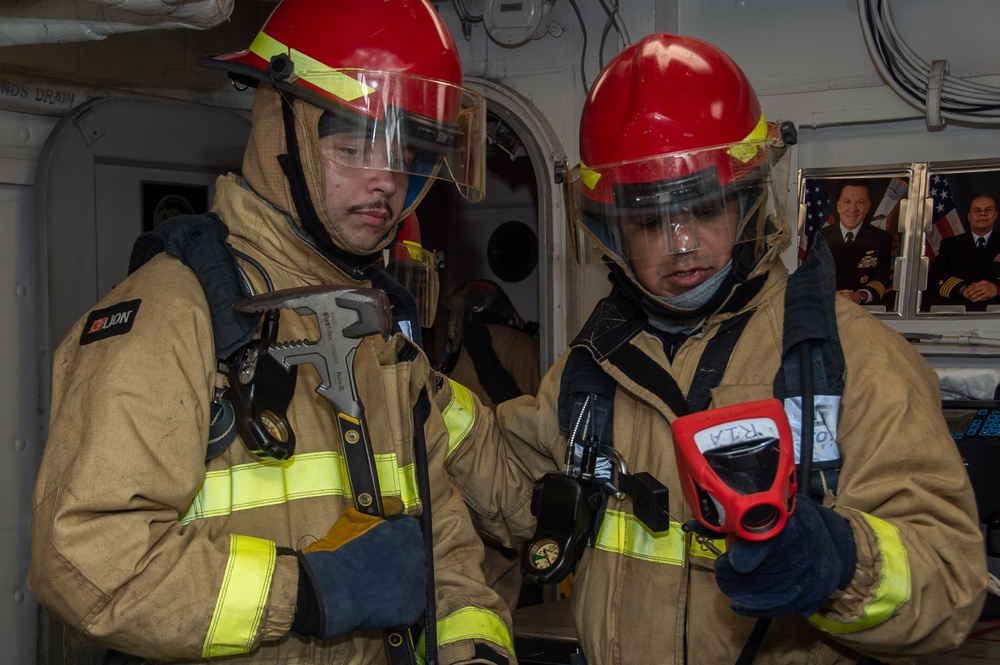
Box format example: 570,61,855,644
809,513,912,635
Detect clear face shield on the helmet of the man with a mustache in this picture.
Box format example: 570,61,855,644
292,67,486,211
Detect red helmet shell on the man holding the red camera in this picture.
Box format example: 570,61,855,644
580,33,767,193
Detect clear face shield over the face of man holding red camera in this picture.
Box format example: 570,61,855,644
568,136,788,286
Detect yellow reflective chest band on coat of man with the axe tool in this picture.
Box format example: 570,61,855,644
181,451,418,524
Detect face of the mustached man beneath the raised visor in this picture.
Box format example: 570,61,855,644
319,132,409,255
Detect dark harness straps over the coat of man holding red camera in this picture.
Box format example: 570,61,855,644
558,239,845,533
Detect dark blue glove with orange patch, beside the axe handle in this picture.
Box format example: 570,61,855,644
292,508,427,640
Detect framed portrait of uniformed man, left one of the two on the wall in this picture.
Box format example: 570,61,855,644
796,165,913,316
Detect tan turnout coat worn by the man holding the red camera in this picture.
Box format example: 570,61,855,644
449,256,987,665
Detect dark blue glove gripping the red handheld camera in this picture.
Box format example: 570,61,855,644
715,494,857,617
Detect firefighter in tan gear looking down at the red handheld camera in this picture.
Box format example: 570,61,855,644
448,34,987,665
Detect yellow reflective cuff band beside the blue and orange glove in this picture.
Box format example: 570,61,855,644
201,535,278,658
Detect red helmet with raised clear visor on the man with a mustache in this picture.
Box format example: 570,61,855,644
200,0,485,208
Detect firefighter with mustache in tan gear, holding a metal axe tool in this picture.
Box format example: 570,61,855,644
29,0,513,665
